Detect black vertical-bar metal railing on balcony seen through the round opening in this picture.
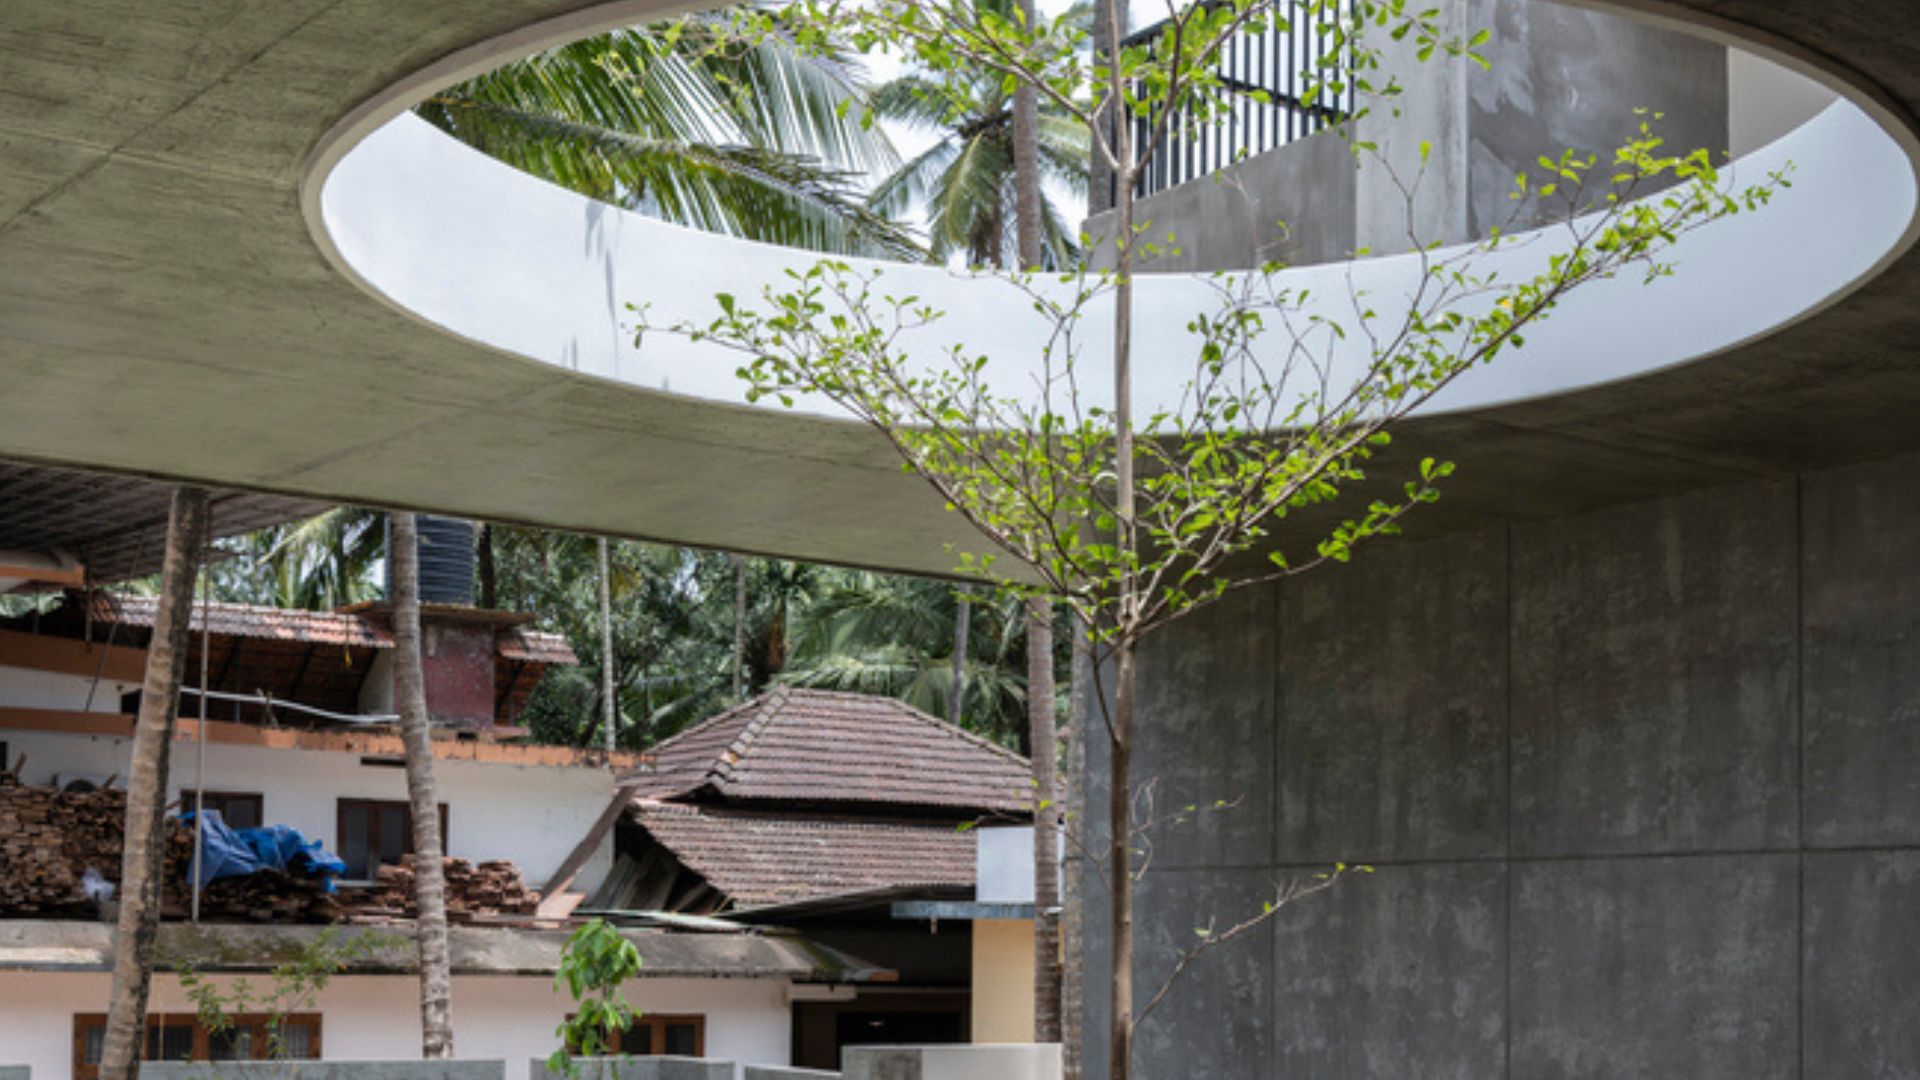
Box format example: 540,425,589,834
1108,0,1354,206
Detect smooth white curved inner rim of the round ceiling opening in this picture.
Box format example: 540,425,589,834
305,10,1920,417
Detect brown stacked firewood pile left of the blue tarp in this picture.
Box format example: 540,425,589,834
0,773,194,917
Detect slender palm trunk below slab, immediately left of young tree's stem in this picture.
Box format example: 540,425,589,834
1027,598,1060,1042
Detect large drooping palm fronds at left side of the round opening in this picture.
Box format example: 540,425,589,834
419,15,924,258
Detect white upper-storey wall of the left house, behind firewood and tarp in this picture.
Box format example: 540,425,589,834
0,718,612,887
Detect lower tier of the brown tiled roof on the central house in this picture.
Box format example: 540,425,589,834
630,799,973,907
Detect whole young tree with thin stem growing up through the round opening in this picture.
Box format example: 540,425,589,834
656,0,1784,1080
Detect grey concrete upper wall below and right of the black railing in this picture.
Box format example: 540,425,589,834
1087,0,1735,271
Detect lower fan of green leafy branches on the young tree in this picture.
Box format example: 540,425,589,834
641,48,1786,640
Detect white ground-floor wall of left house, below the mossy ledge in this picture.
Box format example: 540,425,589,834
0,972,791,1080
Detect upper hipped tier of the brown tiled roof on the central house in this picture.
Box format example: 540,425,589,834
636,688,1033,813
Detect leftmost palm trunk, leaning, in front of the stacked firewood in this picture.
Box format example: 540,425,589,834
100,488,209,1080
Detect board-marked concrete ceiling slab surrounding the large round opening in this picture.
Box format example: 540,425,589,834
0,0,1920,573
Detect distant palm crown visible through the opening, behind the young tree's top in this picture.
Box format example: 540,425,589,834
868,0,1092,269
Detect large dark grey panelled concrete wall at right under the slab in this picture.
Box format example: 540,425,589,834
1087,443,1920,1080
